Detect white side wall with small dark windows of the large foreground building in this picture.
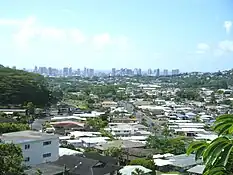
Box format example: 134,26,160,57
19,138,59,166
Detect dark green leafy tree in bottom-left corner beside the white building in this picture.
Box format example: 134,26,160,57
0,144,23,175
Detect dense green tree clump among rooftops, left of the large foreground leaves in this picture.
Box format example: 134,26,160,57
146,136,186,155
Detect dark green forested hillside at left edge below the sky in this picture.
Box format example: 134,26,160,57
0,66,50,106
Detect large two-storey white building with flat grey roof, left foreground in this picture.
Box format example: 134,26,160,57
0,130,59,166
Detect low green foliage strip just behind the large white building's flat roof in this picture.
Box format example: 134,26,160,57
0,123,30,134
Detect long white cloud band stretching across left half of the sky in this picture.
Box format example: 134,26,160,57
0,16,129,50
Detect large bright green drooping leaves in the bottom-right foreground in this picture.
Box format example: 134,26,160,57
187,114,233,175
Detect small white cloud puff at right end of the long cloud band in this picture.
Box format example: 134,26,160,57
93,33,112,50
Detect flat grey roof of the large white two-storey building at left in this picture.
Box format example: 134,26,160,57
0,130,58,144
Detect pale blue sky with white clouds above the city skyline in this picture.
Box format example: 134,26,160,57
0,0,233,71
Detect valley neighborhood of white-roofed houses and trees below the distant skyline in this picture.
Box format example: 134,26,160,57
0,65,233,175
